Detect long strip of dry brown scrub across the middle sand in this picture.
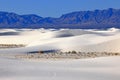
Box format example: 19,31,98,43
15,51,120,59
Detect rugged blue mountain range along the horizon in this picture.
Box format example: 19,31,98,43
0,8,120,29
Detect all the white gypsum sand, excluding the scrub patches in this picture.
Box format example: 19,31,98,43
0,28,120,80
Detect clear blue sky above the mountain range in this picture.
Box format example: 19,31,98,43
0,0,120,18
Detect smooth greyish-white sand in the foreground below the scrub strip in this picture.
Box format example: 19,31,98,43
0,57,120,80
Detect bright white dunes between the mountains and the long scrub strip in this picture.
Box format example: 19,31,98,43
0,28,120,53
